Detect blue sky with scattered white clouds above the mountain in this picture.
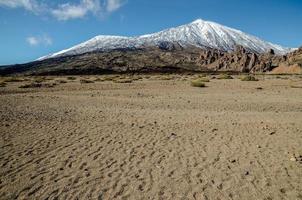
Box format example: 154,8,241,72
0,0,302,65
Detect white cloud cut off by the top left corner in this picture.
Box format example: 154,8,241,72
0,0,43,13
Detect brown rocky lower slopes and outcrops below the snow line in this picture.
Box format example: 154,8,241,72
0,45,302,75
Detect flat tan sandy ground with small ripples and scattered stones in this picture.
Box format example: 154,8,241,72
0,77,302,200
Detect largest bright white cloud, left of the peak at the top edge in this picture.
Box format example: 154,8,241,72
51,0,101,21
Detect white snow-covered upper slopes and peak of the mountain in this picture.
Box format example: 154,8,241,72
38,19,292,60
